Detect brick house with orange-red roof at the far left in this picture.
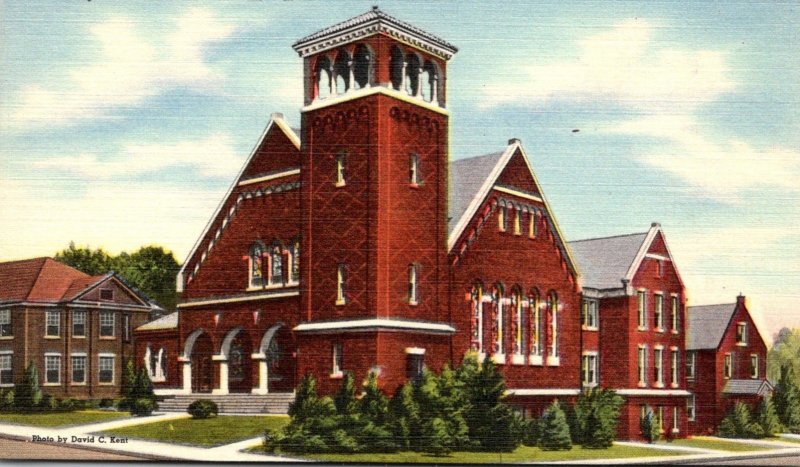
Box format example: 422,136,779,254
0,258,160,399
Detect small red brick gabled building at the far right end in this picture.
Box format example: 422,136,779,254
686,295,772,434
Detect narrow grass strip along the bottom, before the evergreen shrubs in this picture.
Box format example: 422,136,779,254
255,445,685,464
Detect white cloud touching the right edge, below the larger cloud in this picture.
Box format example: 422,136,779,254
601,115,800,201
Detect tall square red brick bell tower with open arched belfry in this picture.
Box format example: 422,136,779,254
293,7,457,392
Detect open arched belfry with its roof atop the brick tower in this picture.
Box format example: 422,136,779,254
293,7,458,108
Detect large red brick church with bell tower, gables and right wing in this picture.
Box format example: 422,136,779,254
131,8,768,438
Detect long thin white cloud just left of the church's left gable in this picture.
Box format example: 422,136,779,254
33,134,244,180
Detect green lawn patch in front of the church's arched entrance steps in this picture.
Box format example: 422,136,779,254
99,415,289,446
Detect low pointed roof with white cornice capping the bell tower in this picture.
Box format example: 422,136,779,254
292,6,458,60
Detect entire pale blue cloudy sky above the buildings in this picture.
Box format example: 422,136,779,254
0,1,800,340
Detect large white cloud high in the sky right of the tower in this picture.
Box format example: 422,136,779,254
482,19,735,109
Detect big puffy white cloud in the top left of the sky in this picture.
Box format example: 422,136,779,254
4,9,234,127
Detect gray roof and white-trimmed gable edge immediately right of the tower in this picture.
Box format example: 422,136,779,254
447,138,580,277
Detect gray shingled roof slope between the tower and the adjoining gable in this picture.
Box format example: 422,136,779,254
447,151,503,235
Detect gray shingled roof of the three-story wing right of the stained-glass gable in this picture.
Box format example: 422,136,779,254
569,232,647,290
